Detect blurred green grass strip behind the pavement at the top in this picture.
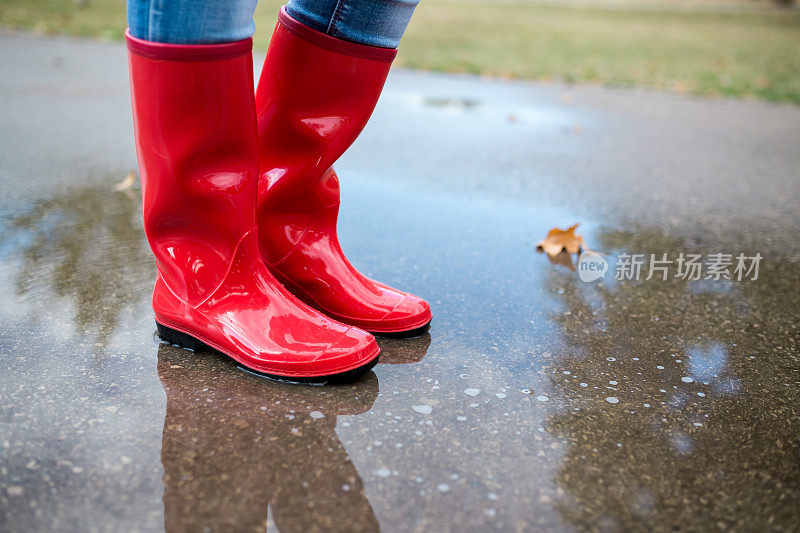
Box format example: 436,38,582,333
0,0,800,104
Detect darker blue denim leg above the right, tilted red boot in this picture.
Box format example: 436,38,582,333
286,0,419,48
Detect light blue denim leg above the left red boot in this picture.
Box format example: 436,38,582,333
128,0,258,44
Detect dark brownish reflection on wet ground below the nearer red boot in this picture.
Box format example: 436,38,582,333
158,344,379,533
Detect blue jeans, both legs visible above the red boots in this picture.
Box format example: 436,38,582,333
128,0,419,48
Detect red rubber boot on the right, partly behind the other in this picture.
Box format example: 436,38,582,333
256,8,431,336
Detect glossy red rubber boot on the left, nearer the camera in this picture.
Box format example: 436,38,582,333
127,31,379,381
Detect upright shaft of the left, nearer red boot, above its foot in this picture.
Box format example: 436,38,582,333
127,35,258,305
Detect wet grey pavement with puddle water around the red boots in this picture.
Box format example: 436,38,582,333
0,34,800,533
